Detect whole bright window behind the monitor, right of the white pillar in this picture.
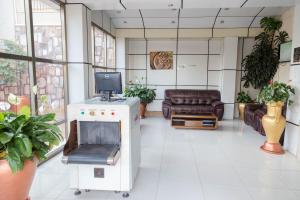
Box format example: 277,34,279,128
92,25,116,71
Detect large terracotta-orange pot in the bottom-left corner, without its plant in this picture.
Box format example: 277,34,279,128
0,159,37,200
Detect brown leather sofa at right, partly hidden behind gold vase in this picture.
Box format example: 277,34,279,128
244,103,286,144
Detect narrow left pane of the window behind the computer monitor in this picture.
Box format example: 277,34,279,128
94,27,106,67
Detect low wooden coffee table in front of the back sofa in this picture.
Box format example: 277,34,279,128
171,112,218,130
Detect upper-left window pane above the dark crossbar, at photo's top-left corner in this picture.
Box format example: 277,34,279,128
0,0,27,55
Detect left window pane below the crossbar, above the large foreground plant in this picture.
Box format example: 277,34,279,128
0,58,31,112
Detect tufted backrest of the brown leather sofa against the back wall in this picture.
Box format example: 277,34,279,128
165,89,221,104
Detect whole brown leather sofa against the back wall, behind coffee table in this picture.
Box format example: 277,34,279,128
162,89,224,120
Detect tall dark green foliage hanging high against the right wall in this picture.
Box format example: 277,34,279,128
242,17,288,89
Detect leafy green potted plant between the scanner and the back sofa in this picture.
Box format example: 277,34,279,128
124,83,156,119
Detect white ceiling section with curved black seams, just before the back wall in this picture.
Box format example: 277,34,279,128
105,7,288,28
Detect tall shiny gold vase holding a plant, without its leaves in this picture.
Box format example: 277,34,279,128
261,101,286,154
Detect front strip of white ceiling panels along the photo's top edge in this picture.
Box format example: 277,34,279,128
67,0,296,10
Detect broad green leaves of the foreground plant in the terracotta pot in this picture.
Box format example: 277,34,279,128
0,113,62,173
